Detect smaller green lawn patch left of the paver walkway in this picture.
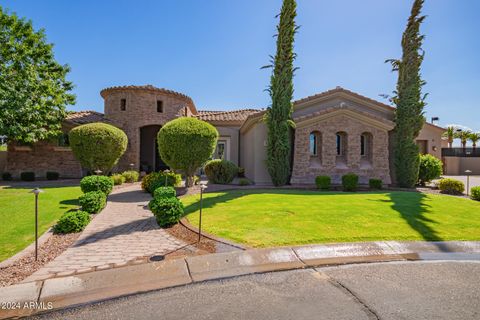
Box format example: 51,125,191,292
0,187,81,261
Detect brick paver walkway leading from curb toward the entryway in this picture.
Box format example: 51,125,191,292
25,184,186,282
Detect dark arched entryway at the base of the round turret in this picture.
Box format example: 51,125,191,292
140,125,168,173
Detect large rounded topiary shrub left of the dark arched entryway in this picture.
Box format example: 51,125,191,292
69,123,128,173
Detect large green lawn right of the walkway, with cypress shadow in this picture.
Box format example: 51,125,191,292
182,189,480,247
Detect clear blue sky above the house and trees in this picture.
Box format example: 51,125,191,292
0,0,480,130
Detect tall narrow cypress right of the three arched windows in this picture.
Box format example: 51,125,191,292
387,0,426,188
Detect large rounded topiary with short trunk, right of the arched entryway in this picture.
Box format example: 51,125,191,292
157,117,218,187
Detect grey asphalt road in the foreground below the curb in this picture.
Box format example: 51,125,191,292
31,261,480,320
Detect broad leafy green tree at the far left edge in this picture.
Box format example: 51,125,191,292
0,7,75,143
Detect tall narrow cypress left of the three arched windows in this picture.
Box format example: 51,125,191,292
265,0,297,186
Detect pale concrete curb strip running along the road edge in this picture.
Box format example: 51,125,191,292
0,241,480,319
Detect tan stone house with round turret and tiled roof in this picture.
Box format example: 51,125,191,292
7,85,445,184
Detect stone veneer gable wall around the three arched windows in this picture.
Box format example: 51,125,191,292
291,115,391,184
